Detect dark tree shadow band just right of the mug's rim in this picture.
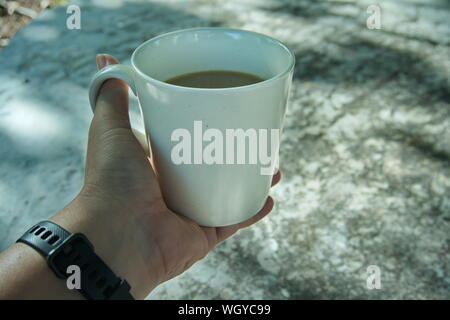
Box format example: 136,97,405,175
294,37,450,107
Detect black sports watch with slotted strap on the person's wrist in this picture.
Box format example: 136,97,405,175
17,221,134,300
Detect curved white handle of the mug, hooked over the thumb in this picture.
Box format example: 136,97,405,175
89,64,150,156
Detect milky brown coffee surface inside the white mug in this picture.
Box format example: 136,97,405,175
165,70,264,89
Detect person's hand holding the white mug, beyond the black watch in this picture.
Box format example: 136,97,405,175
51,55,281,298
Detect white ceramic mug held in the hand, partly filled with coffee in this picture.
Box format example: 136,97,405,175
89,28,295,226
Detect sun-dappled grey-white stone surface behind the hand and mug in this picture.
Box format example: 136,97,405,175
0,0,450,299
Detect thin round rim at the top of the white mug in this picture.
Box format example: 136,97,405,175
131,27,295,92
